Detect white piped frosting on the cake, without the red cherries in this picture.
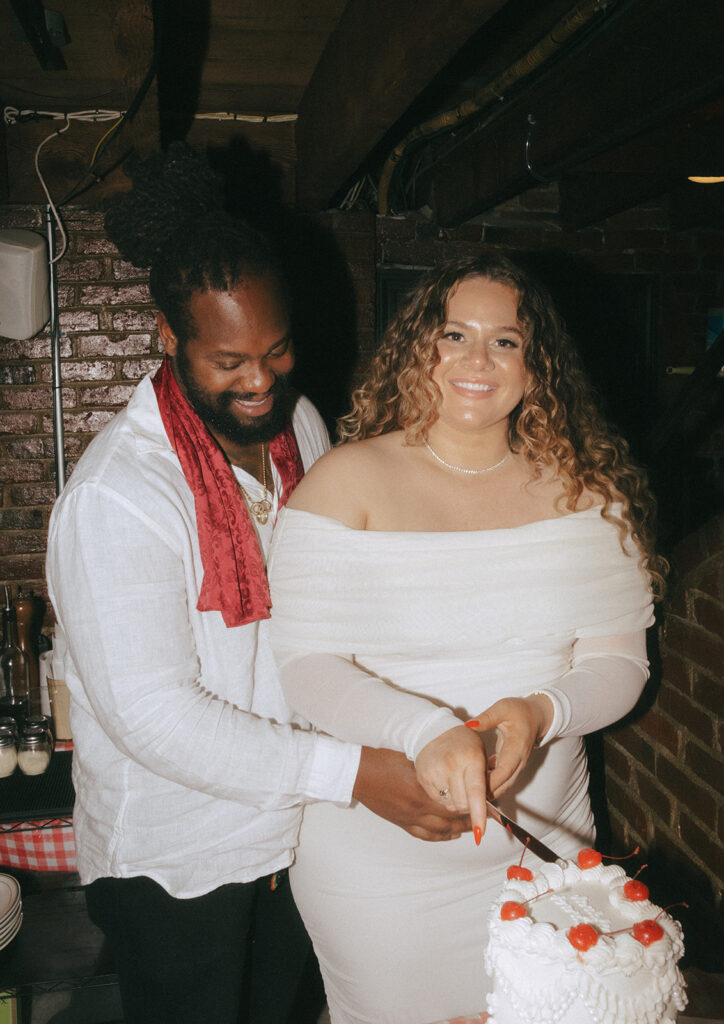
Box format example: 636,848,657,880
485,860,686,1024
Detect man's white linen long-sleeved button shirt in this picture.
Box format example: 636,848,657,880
47,377,359,897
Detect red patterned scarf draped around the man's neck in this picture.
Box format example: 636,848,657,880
153,356,304,626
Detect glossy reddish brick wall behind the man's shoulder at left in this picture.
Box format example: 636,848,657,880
0,199,159,624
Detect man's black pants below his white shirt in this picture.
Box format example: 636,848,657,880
86,871,313,1024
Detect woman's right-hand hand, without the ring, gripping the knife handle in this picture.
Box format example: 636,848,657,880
470,693,553,799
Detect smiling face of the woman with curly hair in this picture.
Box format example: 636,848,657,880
432,276,526,431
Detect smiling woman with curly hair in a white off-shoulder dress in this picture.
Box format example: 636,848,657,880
269,255,665,1024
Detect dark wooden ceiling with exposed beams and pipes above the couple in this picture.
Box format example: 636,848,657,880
0,0,724,229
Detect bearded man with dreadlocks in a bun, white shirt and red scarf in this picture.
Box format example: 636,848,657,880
47,143,469,1024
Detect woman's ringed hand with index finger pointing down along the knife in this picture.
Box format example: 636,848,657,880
415,725,485,844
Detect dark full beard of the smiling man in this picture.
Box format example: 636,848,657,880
176,347,292,445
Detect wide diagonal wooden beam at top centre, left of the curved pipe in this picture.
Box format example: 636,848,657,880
297,0,506,209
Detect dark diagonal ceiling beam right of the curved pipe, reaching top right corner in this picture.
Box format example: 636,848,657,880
423,0,724,224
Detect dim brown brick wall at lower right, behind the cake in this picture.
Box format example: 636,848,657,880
605,516,724,970
